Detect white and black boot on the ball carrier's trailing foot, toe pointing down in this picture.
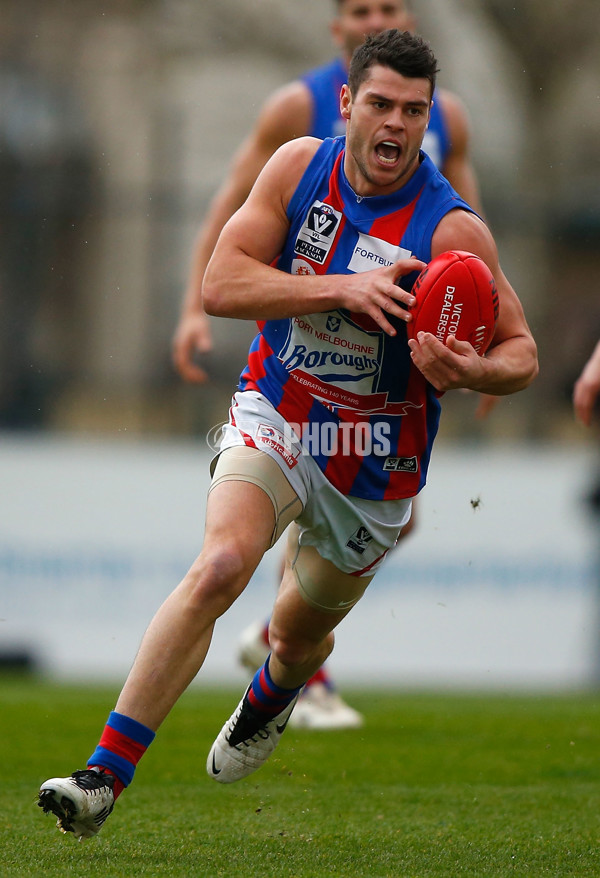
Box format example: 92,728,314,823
206,687,298,783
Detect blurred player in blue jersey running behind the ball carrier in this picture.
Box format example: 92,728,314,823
173,0,482,729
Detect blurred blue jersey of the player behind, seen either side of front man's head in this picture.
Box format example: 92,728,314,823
301,58,450,169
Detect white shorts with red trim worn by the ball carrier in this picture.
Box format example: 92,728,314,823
219,390,412,577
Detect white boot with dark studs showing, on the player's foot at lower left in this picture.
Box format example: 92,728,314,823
38,768,115,841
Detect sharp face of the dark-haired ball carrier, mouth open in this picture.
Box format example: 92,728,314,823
341,64,431,196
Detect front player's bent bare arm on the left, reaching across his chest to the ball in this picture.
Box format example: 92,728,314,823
203,137,424,335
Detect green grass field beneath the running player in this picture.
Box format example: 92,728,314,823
0,677,600,878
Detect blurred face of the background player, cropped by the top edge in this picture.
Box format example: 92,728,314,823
331,0,414,61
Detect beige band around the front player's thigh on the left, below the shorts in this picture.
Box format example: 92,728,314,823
209,445,302,546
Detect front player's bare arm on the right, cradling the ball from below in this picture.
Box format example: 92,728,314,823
409,210,538,396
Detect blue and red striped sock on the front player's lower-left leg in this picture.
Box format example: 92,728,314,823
87,710,156,799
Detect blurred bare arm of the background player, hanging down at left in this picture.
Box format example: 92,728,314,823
173,81,312,381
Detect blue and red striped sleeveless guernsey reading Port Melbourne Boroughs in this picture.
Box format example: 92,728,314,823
239,137,471,500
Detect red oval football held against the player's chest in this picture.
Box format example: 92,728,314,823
407,250,498,356
